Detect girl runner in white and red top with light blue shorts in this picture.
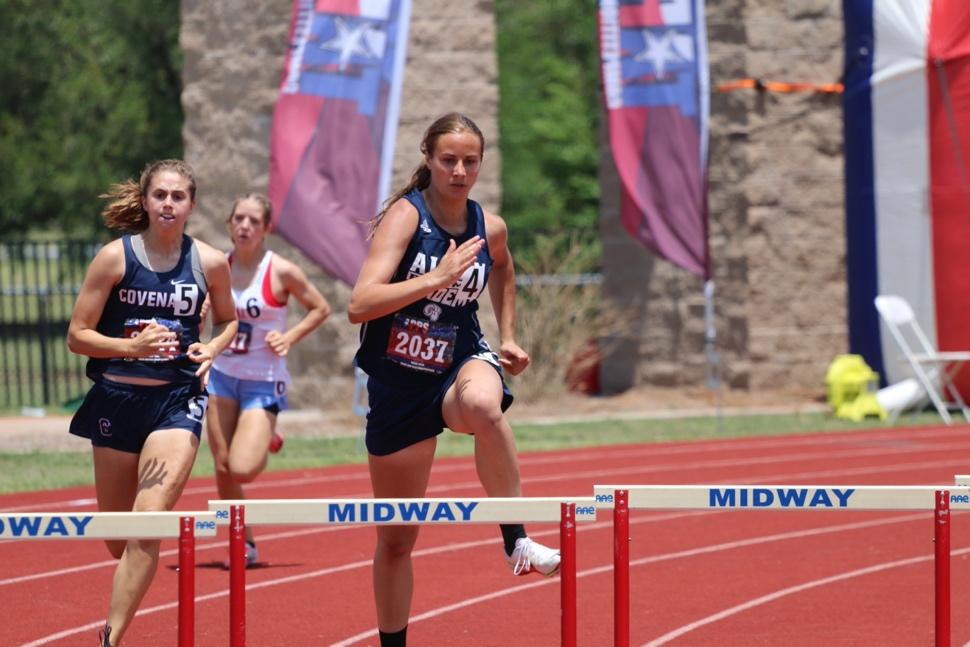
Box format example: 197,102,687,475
206,193,330,566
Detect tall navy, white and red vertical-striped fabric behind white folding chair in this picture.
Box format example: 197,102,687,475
843,0,970,393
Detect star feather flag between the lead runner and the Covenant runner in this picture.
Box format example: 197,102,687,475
269,0,411,285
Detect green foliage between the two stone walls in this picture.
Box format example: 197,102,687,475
495,0,600,266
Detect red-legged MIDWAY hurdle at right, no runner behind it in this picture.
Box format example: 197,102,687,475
593,484,970,647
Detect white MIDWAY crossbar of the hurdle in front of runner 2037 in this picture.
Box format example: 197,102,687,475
209,497,596,525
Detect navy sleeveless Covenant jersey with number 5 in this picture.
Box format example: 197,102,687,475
87,235,206,382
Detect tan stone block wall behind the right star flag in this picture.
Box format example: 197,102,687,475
601,0,848,392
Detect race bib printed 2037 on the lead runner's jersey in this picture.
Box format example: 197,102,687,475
387,314,458,373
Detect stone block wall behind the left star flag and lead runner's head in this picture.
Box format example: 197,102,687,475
180,0,501,408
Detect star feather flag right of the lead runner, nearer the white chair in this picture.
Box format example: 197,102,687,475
599,0,710,279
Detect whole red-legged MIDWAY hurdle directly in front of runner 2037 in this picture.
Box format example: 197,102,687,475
209,497,596,647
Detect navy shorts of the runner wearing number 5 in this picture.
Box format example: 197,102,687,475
70,379,209,454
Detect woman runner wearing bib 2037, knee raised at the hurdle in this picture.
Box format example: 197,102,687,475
348,113,559,646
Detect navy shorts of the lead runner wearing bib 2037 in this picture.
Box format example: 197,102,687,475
364,356,513,456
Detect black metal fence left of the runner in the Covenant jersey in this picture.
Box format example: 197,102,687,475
0,240,101,410
